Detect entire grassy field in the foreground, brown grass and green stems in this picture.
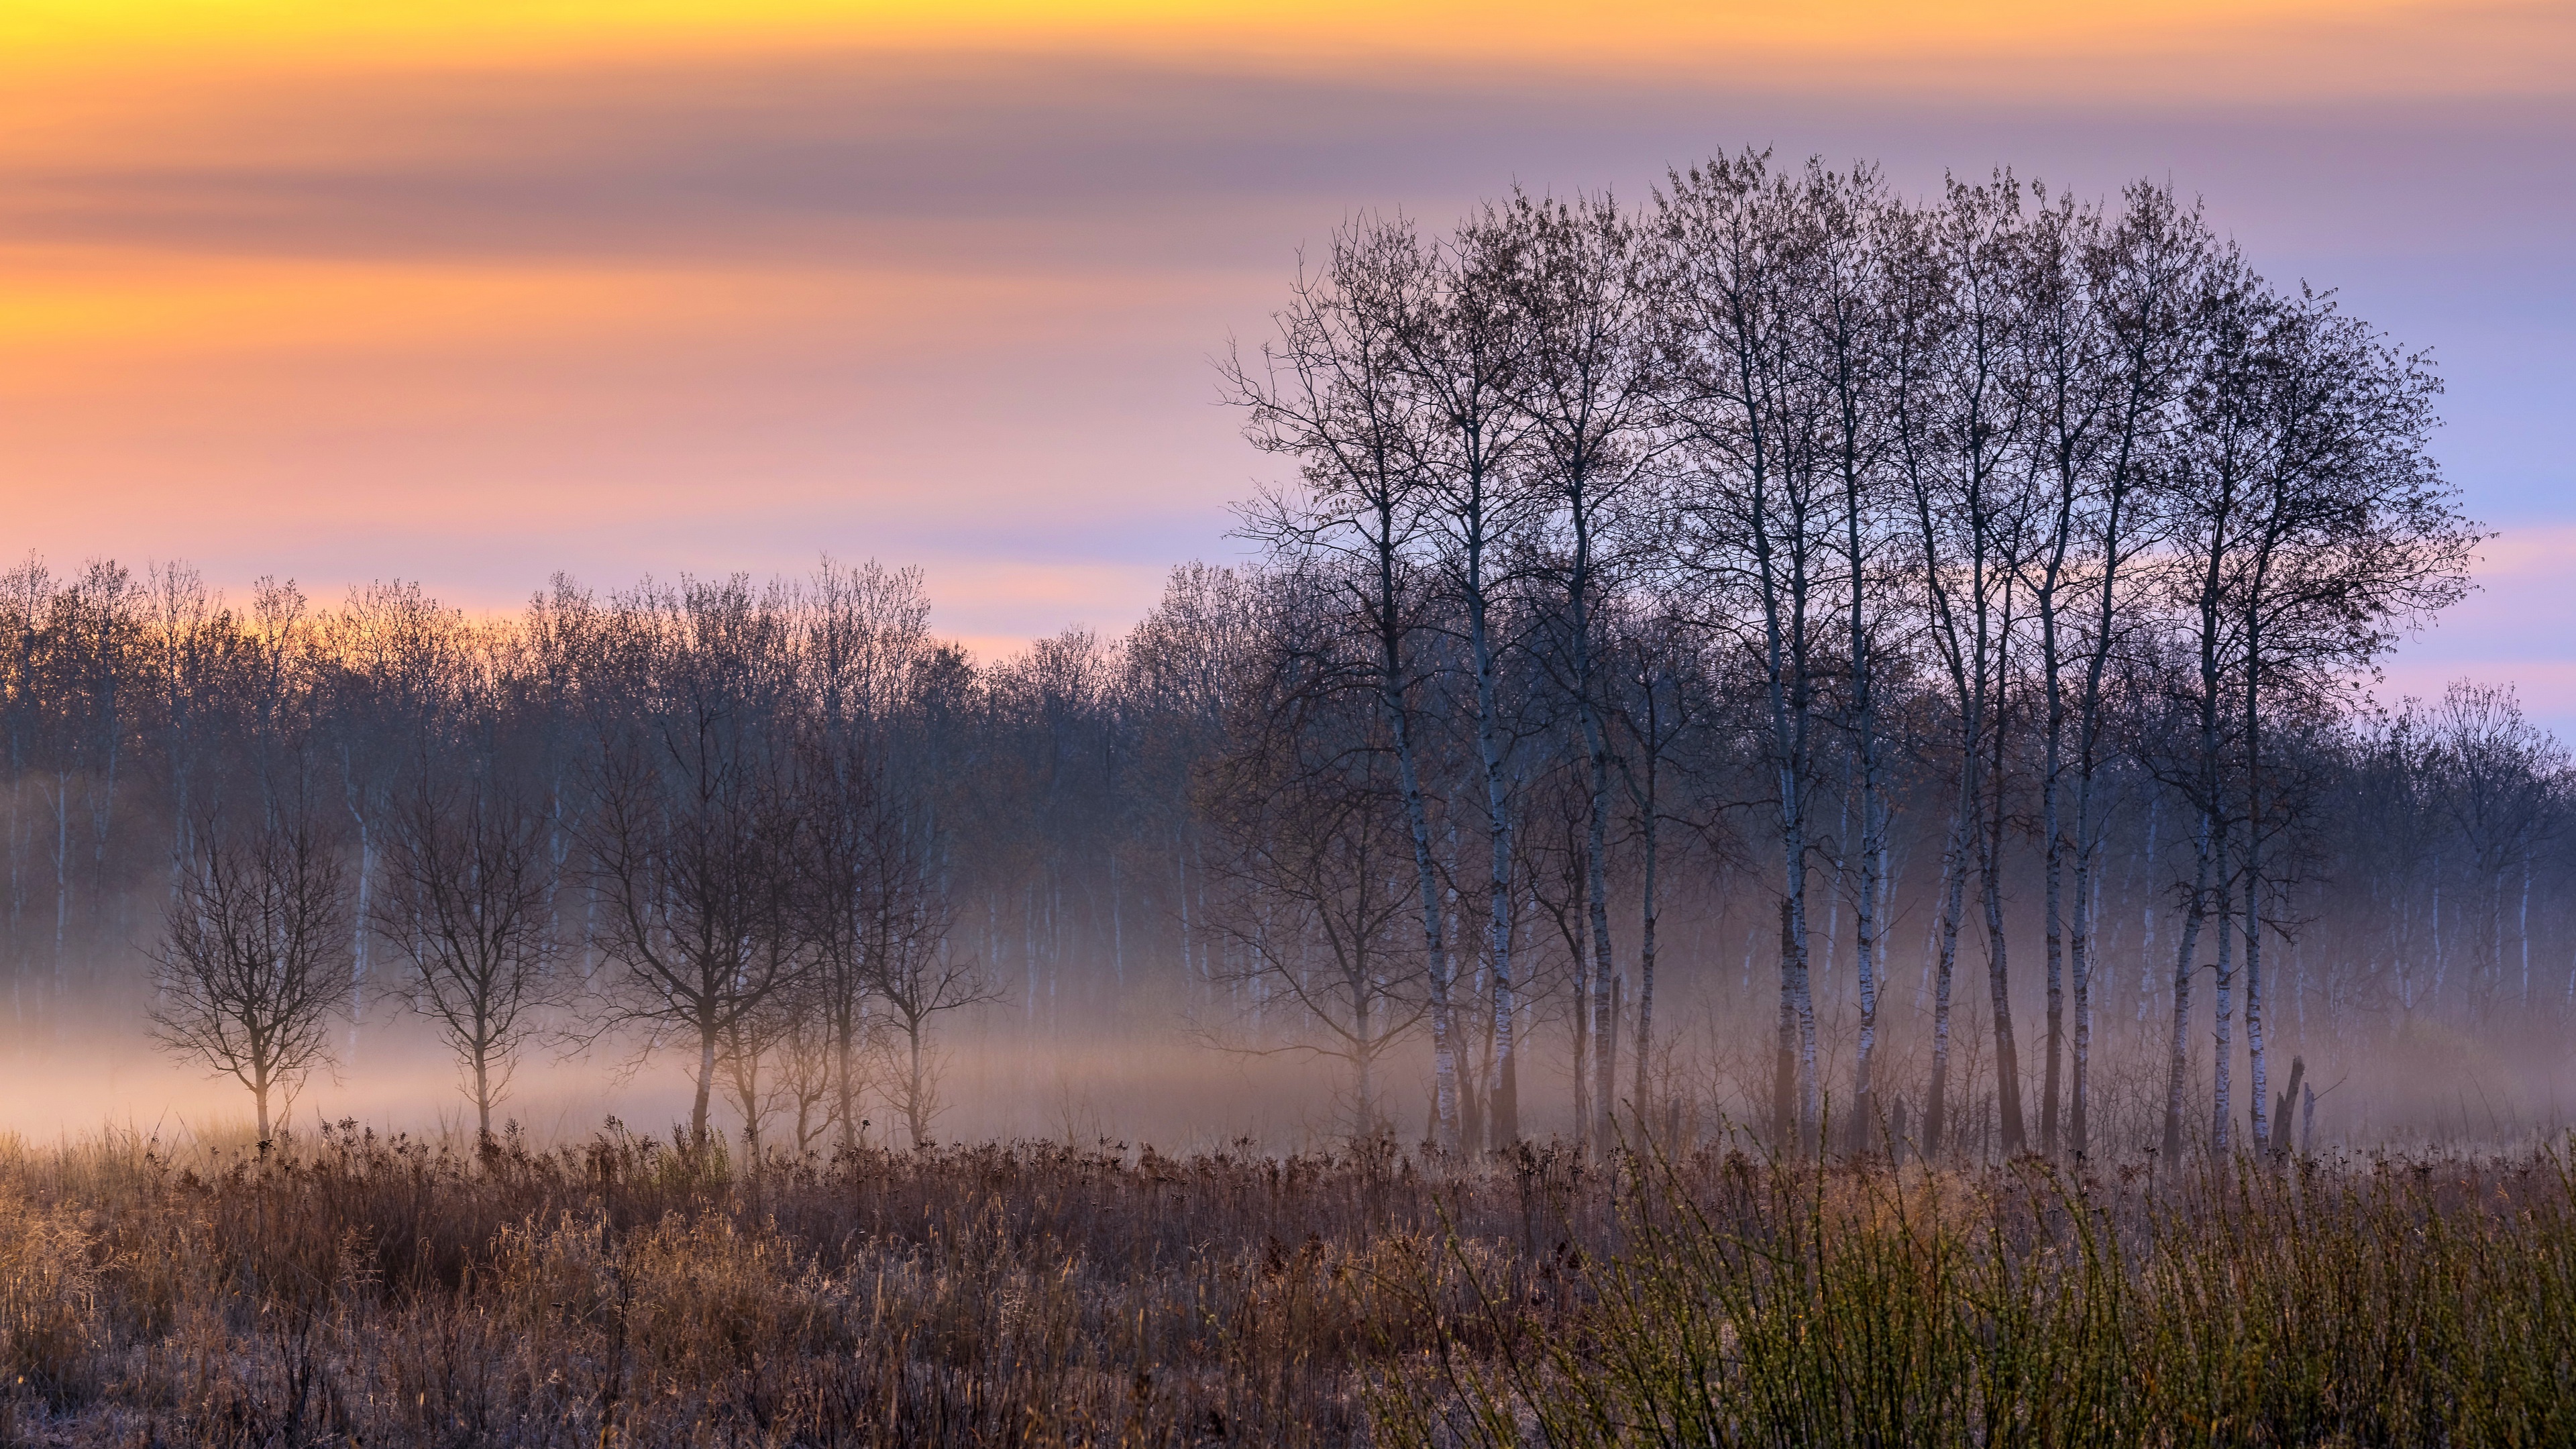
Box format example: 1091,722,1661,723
0,1124,2576,1446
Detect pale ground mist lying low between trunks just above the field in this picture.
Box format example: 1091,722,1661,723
0,964,2576,1163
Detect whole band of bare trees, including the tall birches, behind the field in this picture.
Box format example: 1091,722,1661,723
0,155,2576,1155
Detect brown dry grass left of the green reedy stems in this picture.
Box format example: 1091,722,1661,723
0,1127,1561,1444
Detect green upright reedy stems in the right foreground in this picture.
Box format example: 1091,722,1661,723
1381,1134,2576,1446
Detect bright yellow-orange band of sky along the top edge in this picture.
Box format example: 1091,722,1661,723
0,0,2571,98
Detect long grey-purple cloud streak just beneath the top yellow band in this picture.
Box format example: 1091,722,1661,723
0,52,2576,268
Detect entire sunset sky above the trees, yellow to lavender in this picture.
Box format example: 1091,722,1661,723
0,0,2576,722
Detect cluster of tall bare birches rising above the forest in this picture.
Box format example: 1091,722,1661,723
1226,152,2514,1155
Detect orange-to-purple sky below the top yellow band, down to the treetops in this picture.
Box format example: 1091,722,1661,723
0,52,2576,735
